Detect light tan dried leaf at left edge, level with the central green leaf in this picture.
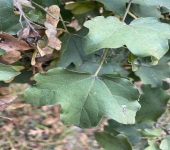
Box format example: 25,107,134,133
0,95,18,111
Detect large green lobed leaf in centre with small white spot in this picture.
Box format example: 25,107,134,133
25,68,140,128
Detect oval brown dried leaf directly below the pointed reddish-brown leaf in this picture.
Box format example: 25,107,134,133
0,51,21,65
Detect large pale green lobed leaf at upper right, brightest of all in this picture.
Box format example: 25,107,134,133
83,16,170,59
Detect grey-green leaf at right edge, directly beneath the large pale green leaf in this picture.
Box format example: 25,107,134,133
135,55,170,87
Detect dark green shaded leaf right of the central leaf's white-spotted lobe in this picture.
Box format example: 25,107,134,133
136,84,170,123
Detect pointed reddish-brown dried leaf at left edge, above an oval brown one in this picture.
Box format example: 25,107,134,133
0,33,32,52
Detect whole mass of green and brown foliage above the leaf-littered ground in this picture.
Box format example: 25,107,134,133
0,0,170,150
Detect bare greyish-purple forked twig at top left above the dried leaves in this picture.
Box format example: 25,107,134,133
14,0,41,37
